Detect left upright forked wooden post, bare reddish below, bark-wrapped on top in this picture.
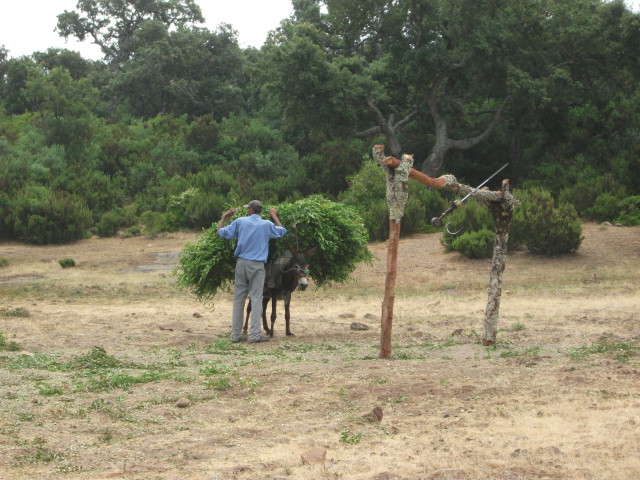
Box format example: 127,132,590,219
373,145,413,358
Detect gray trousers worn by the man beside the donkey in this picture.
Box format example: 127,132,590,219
231,258,264,341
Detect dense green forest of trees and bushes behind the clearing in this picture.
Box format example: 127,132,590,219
0,0,640,251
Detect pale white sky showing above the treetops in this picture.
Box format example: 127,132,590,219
0,0,640,60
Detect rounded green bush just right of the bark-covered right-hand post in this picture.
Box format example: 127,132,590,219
522,188,584,255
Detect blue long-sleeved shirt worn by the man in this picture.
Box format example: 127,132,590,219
218,213,287,263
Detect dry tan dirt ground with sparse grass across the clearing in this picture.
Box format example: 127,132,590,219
0,224,640,480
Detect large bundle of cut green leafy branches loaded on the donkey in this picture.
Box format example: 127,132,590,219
176,195,372,301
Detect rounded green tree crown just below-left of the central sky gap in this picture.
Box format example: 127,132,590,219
111,21,247,121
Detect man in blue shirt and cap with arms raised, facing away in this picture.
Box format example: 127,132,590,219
218,200,287,343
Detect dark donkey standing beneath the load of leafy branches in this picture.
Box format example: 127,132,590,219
242,245,317,337
